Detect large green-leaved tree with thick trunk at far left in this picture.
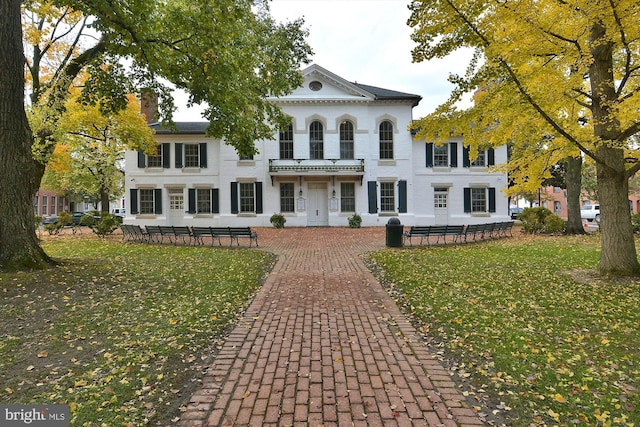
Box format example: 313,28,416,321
0,0,311,266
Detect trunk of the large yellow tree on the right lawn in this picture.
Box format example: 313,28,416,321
589,23,640,276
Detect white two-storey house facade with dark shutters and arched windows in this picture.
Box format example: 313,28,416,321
125,65,509,227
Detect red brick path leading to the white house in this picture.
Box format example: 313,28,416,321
179,227,484,427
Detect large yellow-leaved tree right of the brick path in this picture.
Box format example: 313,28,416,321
409,0,640,275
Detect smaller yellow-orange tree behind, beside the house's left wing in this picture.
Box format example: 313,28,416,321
43,91,156,213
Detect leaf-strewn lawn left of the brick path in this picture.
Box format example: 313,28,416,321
0,237,272,426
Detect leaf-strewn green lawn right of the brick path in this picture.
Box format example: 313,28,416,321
369,236,640,426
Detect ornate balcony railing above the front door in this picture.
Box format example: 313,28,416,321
269,159,364,175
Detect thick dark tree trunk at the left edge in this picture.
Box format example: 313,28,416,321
0,0,51,269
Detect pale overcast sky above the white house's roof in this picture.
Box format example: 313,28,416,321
174,0,470,121
